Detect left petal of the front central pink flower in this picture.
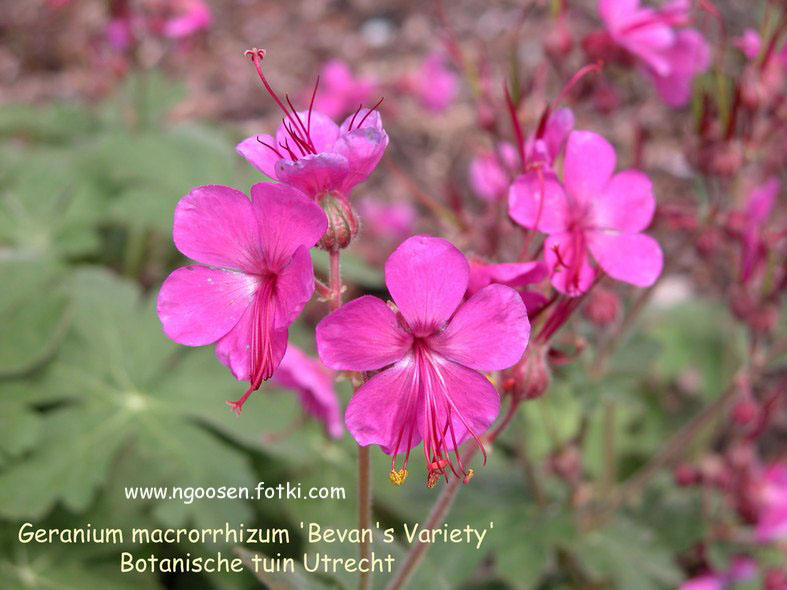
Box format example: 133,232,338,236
317,295,413,371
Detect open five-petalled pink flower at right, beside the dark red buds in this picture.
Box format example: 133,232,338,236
508,131,662,296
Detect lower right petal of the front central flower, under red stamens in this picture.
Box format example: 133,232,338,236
418,360,500,450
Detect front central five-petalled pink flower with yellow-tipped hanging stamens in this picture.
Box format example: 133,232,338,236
317,236,530,487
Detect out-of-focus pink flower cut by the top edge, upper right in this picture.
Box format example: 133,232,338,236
599,0,710,107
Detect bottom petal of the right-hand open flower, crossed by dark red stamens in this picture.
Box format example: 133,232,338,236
544,232,596,297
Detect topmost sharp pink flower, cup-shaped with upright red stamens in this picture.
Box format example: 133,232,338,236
236,50,388,199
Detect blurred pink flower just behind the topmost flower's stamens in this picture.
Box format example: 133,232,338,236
314,59,378,118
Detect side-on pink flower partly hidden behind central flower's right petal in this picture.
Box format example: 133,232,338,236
466,258,547,315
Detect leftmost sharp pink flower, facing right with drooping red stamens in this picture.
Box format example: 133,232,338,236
158,183,327,413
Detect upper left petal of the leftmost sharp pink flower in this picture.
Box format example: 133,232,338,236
172,185,263,272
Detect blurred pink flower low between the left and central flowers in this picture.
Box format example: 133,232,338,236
272,344,344,438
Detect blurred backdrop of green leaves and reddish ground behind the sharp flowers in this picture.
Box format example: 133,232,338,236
0,0,787,590
